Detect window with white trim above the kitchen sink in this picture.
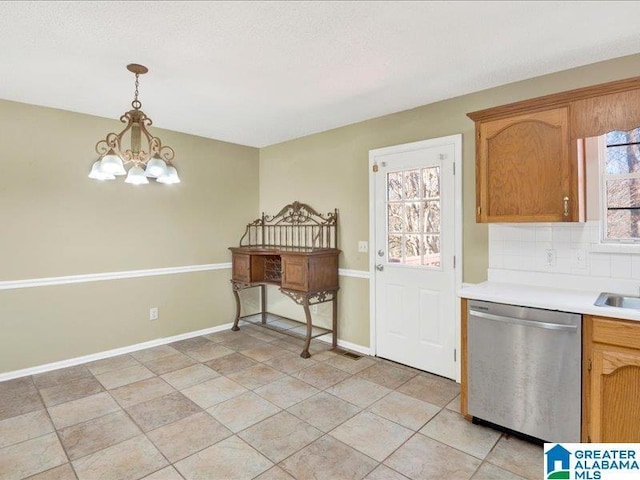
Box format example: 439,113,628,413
600,128,640,244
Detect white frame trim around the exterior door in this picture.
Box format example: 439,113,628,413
369,133,463,382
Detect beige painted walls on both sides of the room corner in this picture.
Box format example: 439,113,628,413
0,55,640,373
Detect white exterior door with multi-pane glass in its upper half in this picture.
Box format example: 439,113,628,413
371,136,460,378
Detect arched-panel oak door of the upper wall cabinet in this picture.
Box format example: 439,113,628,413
477,108,577,222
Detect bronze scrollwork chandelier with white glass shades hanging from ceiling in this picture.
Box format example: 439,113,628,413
89,63,180,185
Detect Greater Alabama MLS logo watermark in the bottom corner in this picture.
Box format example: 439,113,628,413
544,443,640,480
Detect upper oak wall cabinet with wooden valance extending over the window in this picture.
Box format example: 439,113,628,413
467,77,640,222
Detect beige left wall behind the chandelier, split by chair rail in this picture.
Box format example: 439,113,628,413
0,101,259,372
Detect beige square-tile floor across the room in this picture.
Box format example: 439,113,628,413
0,325,542,480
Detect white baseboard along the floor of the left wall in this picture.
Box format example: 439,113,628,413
0,323,233,382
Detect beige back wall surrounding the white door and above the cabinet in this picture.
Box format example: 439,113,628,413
260,55,640,345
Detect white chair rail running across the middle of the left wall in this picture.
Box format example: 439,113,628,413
0,263,231,290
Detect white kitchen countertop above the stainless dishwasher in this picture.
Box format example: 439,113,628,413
458,281,640,321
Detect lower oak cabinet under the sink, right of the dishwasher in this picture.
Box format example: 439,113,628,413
582,315,640,443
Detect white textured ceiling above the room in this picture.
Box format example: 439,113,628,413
0,1,640,147
